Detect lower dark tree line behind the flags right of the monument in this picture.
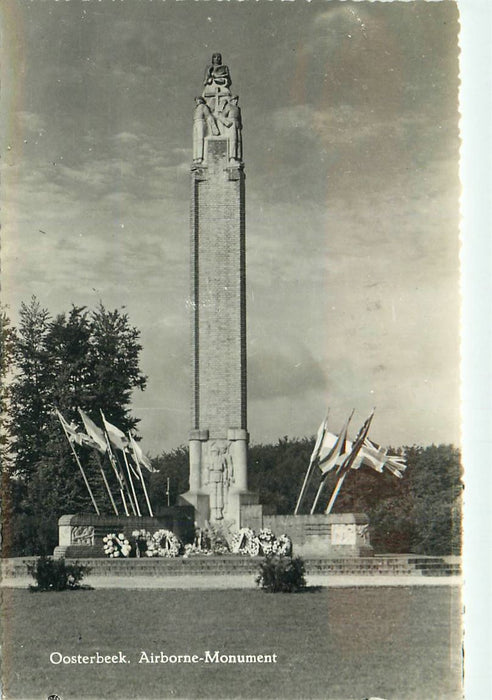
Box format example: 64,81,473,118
249,437,462,555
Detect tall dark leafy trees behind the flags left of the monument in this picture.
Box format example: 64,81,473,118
4,298,146,554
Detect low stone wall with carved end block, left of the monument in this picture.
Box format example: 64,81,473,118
53,506,195,559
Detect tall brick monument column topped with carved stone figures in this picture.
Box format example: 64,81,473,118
182,54,258,527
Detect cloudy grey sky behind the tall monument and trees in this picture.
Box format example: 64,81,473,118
1,0,460,454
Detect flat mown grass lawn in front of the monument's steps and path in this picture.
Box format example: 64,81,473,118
2,586,461,700
